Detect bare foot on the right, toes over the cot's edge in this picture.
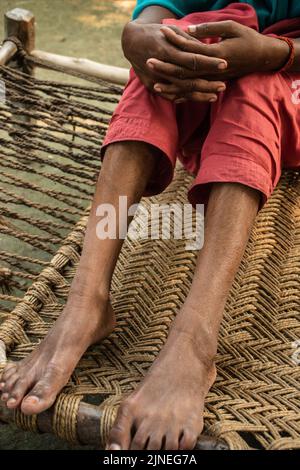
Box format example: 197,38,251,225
107,328,216,450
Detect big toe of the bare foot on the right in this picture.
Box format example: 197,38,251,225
106,402,133,450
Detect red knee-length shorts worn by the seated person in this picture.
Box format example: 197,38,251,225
103,3,300,205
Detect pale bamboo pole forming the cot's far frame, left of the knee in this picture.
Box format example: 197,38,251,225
28,50,129,85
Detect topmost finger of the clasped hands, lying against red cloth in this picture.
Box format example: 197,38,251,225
188,20,241,39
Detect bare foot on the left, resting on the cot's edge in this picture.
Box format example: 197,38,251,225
0,291,115,415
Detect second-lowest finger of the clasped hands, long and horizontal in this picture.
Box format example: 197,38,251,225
154,79,226,95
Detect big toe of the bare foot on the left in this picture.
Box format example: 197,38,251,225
21,380,58,415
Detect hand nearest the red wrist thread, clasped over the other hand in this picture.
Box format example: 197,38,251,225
147,21,292,99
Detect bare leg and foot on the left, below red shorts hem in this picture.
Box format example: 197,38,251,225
0,142,159,414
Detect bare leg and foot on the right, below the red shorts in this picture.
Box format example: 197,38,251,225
107,183,260,450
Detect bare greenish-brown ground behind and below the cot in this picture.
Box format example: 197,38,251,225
0,0,136,450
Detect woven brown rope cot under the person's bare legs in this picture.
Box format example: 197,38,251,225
0,21,300,449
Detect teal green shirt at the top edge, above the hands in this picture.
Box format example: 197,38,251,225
133,0,300,31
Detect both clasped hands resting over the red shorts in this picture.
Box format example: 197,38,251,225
122,6,292,101
